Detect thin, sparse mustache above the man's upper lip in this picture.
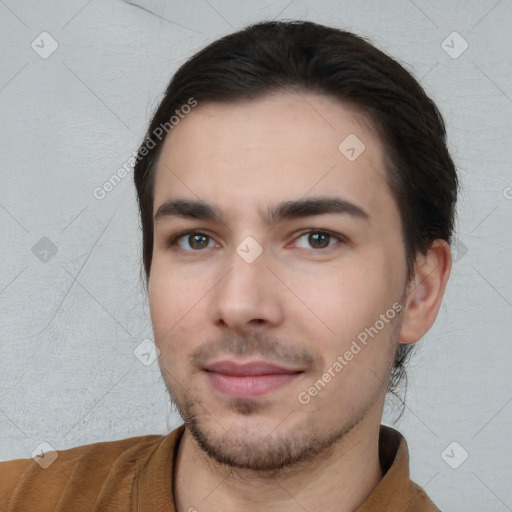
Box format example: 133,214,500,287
189,331,321,370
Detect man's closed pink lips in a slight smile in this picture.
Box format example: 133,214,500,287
203,360,304,398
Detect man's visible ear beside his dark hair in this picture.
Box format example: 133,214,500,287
399,240,452,344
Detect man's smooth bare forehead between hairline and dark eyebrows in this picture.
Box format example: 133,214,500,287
154,92,396,226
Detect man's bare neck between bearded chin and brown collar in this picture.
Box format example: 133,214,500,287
174,416,383,512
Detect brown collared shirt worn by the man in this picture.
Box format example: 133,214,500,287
0,425,439,512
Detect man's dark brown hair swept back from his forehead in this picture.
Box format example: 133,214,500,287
134,21,458,401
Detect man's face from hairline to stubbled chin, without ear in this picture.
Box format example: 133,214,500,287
149,92,407,469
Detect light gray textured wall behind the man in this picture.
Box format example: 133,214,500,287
0,0,512,512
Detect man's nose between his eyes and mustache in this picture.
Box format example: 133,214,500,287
211,244,285,333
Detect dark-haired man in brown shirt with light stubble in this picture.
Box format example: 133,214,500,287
0,18,457,512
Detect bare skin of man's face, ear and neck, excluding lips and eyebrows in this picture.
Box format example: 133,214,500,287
149,92,450,511
